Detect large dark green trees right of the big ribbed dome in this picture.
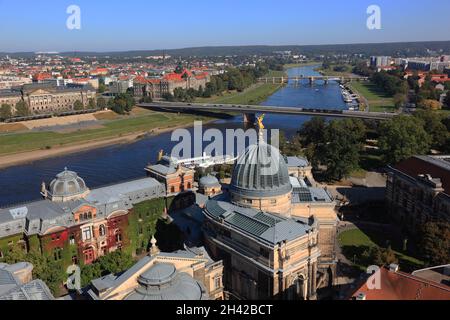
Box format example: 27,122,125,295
296,110,450,180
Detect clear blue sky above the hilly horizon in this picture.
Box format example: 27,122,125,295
0,0,450,52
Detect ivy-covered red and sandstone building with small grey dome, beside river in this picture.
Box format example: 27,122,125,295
0,169,168,266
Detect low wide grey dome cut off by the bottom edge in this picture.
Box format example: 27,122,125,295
126,263,208,301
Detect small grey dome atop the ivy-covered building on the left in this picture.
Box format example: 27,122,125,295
50,168,88,197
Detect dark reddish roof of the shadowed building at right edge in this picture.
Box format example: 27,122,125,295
394,156,450,194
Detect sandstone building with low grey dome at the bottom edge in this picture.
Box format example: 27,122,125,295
87,244,224,301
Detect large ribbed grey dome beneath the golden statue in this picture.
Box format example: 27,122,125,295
230,140,292,197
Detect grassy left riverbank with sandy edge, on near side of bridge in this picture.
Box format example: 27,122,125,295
0,112,216,168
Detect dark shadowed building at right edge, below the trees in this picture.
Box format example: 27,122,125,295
386,156,450,234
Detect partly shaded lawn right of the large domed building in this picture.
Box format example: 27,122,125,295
338,229,424,272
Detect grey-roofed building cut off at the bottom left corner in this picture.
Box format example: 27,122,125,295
0,262,55,300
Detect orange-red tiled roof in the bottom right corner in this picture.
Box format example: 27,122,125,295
353,267,450,300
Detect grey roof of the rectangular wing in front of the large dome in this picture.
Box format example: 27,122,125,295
204,200,312,245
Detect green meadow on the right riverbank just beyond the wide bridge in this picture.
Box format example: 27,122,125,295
350,81,396,112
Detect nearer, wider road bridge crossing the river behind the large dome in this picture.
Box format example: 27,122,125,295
138,102,398,123
